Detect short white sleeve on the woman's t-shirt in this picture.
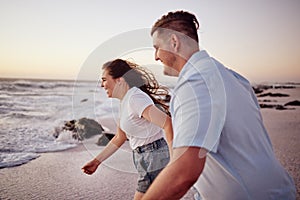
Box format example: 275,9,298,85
129,92,154,117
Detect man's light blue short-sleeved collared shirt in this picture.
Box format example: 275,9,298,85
170,51,296,200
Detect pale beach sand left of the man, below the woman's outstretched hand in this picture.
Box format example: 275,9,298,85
0,138,193,200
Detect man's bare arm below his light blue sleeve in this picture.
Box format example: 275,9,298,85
142,147,206,200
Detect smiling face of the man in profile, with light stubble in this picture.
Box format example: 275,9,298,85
152,31,179,76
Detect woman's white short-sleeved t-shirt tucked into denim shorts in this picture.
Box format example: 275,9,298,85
120,87,164,149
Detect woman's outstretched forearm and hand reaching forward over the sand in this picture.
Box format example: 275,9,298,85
82,127,127,175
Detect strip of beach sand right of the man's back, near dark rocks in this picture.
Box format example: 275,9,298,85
261,88,300,199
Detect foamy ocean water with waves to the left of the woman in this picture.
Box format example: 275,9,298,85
0,79,119,168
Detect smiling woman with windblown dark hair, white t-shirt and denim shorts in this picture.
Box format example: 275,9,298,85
82,59,173,199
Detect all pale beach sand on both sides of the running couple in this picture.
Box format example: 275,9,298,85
0,89,300,199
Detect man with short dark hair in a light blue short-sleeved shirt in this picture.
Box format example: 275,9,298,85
143,11,296,200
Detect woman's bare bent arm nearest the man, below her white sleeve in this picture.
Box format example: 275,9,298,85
142,105,173,157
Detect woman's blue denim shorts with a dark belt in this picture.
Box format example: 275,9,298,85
133,138,170,193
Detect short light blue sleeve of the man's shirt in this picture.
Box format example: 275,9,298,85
171,60,226,152
